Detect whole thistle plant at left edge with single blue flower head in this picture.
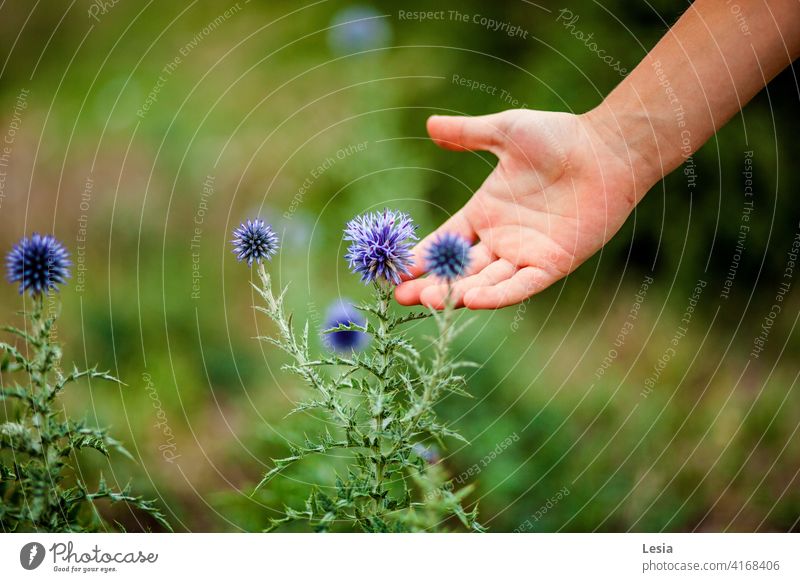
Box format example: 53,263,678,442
0,234,170,532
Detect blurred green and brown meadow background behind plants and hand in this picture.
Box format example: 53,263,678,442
0,0,800,531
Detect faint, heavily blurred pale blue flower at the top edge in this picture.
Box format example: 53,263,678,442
328,6,392,54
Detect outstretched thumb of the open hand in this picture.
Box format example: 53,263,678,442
428,113,506,154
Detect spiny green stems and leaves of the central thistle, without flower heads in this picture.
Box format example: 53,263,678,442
254,266,483,532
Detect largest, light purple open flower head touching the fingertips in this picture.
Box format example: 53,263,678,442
344,209,417,285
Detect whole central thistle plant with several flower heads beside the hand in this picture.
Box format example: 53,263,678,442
234,210,483,532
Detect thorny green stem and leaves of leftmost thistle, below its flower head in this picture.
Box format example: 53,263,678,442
0,296,171,532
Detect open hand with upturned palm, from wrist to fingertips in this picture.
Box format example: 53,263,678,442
395,110,655,309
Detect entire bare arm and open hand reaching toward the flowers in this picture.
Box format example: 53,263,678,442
395,0,800,309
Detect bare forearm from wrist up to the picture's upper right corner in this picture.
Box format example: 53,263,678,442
586,0,800,197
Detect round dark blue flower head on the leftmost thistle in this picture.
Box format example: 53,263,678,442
6,233,72,296
